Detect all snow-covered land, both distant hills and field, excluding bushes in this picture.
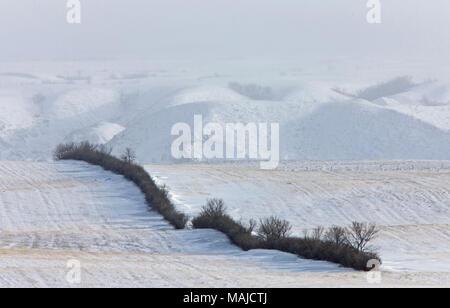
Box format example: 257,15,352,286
0,59,450,287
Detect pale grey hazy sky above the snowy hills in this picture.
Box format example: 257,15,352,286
0,0,450,60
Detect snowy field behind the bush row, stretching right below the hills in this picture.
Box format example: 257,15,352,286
146,161,450,276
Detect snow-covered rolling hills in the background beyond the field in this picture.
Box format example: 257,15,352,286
0,63,450,163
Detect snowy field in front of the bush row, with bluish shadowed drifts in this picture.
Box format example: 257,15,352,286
0,162,449,287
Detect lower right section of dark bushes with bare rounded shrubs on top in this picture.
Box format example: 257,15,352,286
192,199,381,270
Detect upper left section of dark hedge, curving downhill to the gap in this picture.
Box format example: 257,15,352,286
54,142,188,229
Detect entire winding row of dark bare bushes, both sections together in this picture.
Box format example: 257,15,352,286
54,142,381,270
